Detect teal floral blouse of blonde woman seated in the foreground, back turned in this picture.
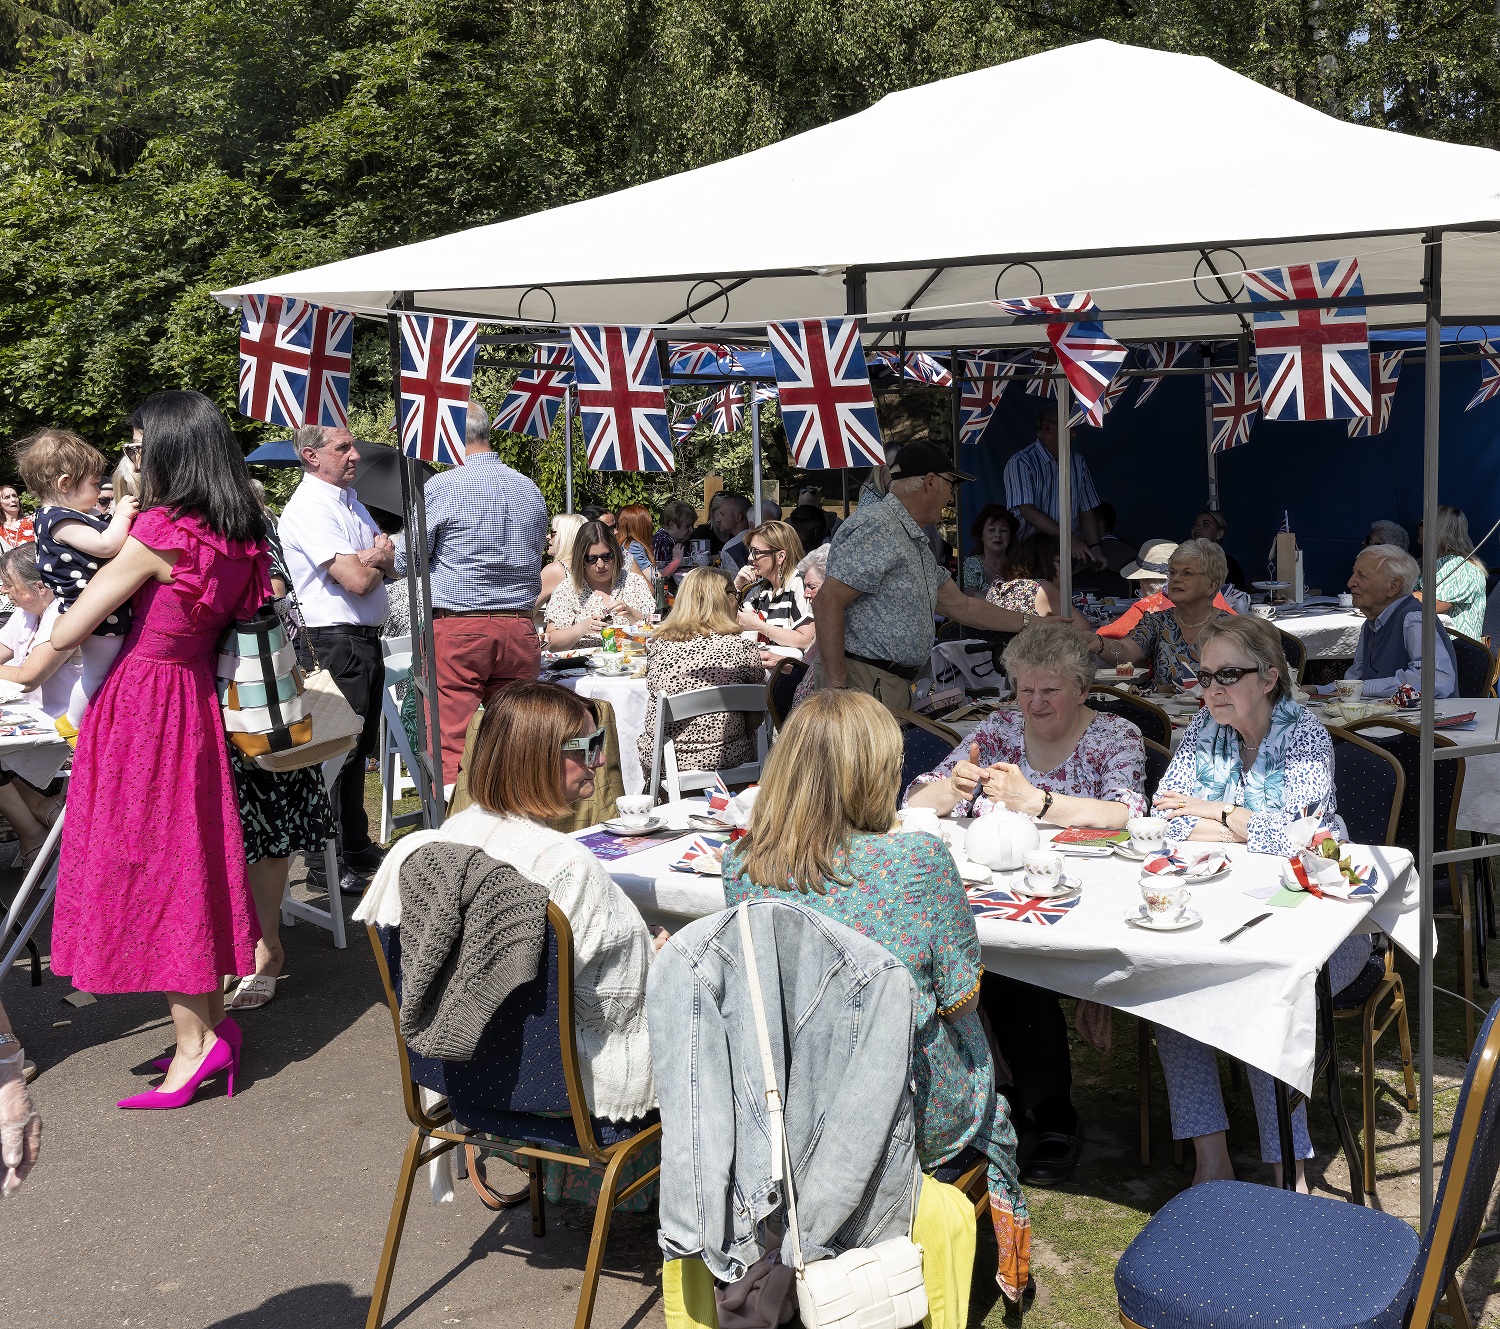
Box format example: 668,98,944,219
725,831,995,1170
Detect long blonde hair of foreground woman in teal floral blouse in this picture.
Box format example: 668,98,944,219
735,689,902,896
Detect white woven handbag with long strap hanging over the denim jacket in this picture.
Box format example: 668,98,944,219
737,900,927,1329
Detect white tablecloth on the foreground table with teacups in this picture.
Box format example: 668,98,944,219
584,801,1419,1092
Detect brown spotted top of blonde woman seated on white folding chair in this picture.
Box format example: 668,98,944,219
636,636,765,773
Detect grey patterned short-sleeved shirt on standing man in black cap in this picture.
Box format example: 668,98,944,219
828,494,948,668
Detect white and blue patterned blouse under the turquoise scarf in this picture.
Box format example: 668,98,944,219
1158,707,1344,854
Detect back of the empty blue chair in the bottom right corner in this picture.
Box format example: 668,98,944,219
1407,1002,1500,1326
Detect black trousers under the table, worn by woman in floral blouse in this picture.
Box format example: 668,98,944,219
980,972,1079,1136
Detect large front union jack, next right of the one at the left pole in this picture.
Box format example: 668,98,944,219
573,324,672,471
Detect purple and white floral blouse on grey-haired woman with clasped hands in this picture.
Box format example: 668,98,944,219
906,711,1146,818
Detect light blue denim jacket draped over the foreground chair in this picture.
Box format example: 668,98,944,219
647,900,917,1283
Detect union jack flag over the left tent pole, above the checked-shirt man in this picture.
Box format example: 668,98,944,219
401,314,479,467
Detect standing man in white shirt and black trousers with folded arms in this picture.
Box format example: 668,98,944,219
278,425,396,890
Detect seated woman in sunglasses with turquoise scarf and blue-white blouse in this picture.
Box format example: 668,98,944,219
1155,618,1370,1191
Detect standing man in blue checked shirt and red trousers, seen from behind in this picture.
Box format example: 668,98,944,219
396,402,548,786
